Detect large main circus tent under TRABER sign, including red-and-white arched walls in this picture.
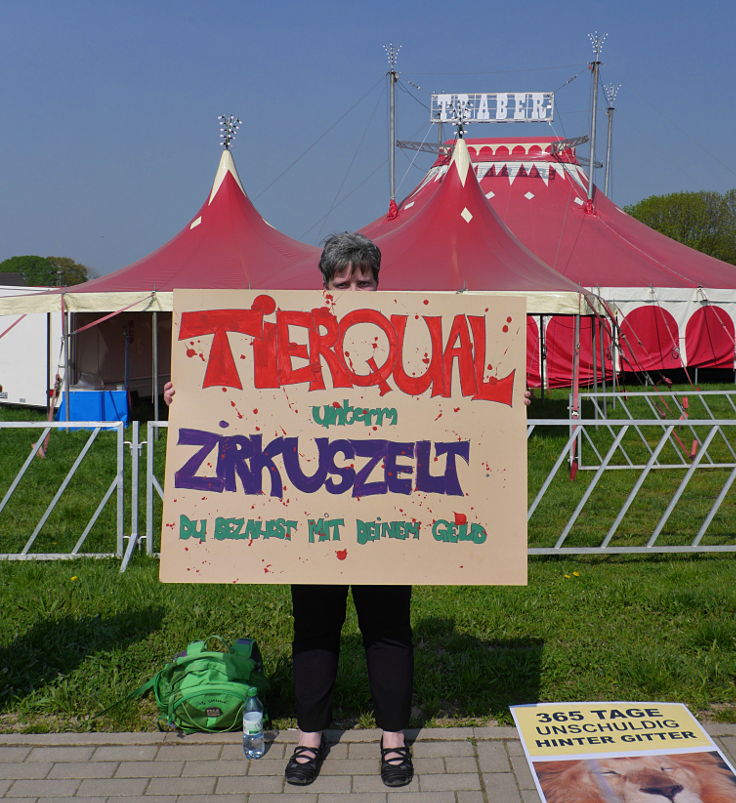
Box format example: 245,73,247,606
364,137,736,385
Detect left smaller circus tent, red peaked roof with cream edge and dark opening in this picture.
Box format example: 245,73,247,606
0,149,319,394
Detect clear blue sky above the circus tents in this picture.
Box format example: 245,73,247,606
0,0,736,273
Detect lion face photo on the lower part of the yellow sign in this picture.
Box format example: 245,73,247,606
534,753,736,803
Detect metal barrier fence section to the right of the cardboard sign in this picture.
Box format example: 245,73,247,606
527,419,736,555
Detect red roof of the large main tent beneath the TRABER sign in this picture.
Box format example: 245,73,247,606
392,137,736,288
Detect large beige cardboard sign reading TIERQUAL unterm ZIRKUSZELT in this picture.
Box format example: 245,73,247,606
161,291,526,584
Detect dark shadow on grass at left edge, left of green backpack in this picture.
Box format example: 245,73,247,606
0,606,165,711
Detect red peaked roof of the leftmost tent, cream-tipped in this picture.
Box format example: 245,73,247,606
71,150,319,293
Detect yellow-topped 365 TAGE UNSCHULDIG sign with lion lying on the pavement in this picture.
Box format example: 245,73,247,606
511,702,736,803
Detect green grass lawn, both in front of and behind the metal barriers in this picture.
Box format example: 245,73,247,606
0,391,736,732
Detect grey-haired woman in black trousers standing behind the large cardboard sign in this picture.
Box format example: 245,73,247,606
164,232,414,787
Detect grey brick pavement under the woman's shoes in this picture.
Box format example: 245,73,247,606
0,723,736,803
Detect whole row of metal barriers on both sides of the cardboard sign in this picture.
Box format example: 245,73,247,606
0,417,736,571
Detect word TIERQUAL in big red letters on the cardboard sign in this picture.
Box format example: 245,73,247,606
179,295,514,405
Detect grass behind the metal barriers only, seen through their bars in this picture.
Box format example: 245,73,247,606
0,386,736,553
